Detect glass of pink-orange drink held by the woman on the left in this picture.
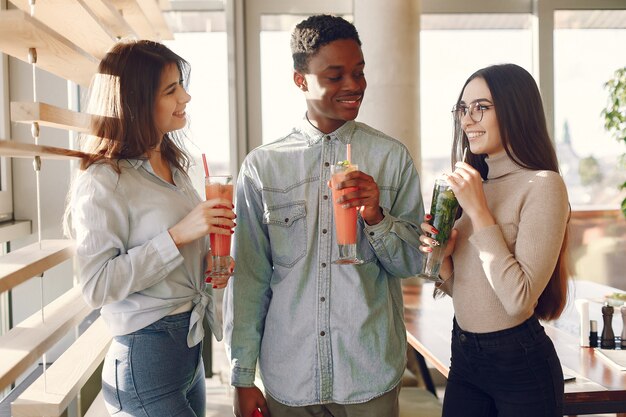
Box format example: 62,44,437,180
204,175,234,277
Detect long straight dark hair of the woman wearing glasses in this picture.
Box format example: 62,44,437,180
452,64,569,320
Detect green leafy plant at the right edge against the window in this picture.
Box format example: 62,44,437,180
602,67,626,217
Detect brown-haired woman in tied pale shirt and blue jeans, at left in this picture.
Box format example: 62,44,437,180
67,41,235,417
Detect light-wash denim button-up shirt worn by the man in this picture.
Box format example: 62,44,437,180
224,120,424,406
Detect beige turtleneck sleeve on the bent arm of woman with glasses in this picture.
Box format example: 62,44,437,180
469,171,569,316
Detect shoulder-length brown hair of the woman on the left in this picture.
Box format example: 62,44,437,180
81,40,190,173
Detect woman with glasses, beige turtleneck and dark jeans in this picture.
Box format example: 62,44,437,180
420,64,570,417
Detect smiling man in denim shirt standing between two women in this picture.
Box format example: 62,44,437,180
224,15,424,417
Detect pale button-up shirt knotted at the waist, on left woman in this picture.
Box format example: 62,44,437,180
71,159,222,346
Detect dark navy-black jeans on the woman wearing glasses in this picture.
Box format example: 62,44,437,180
443,317,563,417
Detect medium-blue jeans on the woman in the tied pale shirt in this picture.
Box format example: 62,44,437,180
102,312,206,417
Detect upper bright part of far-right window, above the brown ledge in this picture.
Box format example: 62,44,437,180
554,10,626,210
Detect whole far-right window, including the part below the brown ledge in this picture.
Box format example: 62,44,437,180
554,10,626,289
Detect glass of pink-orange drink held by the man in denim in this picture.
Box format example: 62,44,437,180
330,161,363,264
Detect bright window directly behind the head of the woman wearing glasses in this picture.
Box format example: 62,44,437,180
420,14,533,202
